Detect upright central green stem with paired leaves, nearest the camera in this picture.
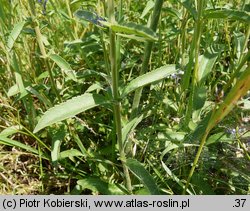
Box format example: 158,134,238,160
108,0,132,193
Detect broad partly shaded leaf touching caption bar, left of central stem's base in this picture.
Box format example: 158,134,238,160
77,177,125,195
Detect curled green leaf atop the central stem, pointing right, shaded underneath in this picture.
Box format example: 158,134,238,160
102,21,157,41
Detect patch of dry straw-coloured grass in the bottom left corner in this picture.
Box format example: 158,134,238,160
0,147,42,195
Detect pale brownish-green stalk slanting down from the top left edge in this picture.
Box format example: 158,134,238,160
29,0,62,102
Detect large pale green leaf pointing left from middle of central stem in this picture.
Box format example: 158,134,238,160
34,93,107,133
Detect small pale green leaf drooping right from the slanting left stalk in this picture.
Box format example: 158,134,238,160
49,54,77,81
